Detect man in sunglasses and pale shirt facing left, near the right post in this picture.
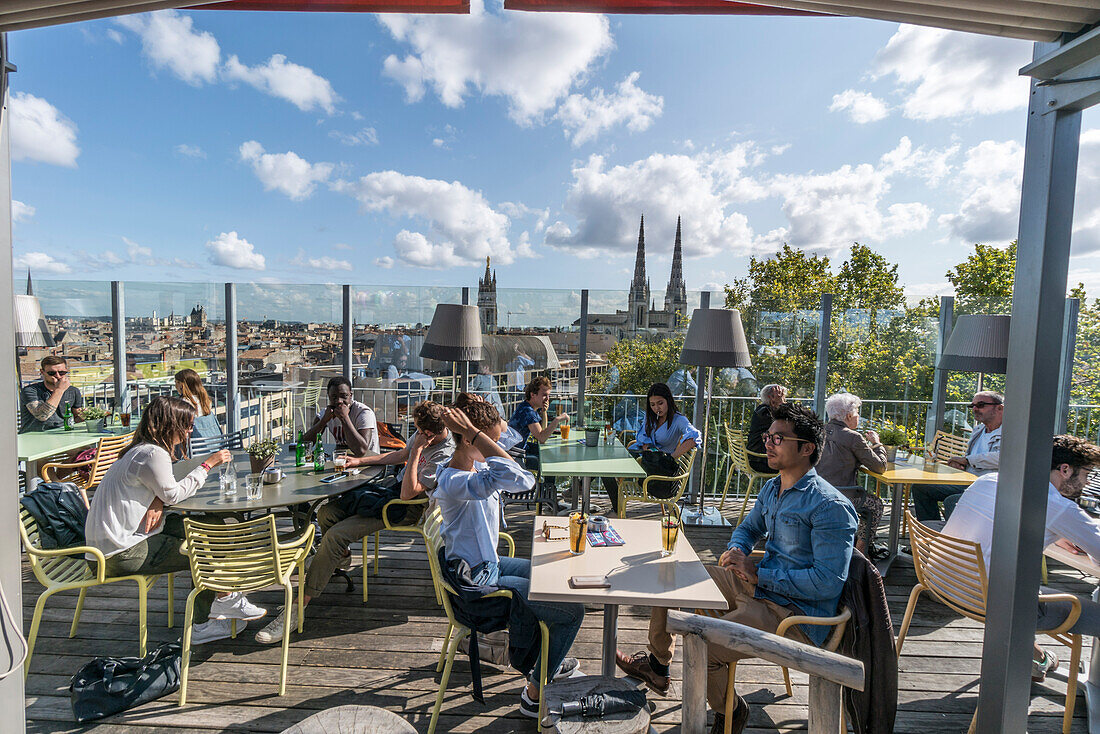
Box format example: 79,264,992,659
913,391,1004,523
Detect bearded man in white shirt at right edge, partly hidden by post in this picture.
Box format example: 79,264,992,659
943,436,1100,682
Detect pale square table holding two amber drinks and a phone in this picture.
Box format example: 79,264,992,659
528,515,729,676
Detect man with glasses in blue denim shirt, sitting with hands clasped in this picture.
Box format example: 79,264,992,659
616,403,857,734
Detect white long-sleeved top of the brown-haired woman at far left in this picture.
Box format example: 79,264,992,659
84,443,207,558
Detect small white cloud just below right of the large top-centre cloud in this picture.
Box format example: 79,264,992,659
554,72,664,146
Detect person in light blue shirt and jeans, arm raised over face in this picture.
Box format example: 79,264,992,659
432,399,584,717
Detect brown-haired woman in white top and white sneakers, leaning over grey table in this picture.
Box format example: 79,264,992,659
85,397,266,645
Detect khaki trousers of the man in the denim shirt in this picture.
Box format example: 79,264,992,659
649,566,813,712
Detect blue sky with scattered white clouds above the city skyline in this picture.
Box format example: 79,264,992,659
10,5,1100,316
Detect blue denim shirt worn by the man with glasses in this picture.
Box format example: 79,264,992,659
727,469,857,645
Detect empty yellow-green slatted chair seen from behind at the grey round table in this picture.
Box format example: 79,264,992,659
179,515,314,705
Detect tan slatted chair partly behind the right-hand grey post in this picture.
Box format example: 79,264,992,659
898,511,1081,734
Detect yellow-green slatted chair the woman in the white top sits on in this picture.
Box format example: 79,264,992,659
19,507,175,678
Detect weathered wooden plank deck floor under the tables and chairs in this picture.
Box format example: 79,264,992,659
19,508,1091,734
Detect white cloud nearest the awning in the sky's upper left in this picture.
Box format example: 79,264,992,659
116,10,221,87
